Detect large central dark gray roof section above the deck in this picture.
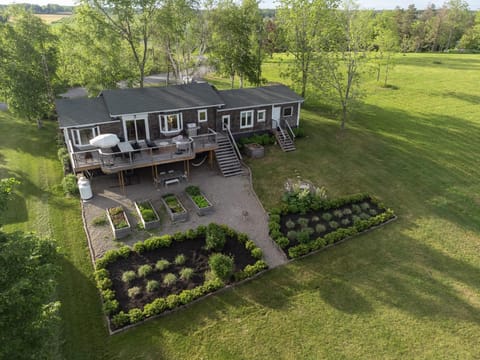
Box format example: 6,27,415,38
101,83,223,115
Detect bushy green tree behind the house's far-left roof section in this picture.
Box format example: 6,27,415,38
54,6,136,96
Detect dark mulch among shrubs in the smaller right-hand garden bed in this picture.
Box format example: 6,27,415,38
280,199,385,248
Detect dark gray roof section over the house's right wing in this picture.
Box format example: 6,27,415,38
218,85,303,109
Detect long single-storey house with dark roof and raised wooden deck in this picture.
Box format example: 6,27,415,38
56,83,303,176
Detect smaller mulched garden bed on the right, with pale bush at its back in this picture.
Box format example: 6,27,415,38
269,190,395,258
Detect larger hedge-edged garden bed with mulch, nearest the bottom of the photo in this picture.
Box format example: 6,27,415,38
95,224,267,331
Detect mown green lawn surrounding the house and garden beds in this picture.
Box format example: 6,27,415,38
0,55,480,360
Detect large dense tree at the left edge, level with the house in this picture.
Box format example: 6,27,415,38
0,7,57,127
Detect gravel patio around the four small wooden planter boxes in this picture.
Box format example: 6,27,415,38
83,166,287,267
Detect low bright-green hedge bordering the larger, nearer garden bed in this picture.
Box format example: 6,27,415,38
94,224,267,328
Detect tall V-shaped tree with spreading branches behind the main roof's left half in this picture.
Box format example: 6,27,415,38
82,0,159,87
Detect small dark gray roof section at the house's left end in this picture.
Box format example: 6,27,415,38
55,98,112,128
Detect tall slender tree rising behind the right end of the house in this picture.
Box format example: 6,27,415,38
278,0,337,97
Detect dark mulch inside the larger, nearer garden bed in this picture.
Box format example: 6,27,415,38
107,236,256,311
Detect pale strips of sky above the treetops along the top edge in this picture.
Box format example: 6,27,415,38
0,0,480,10
